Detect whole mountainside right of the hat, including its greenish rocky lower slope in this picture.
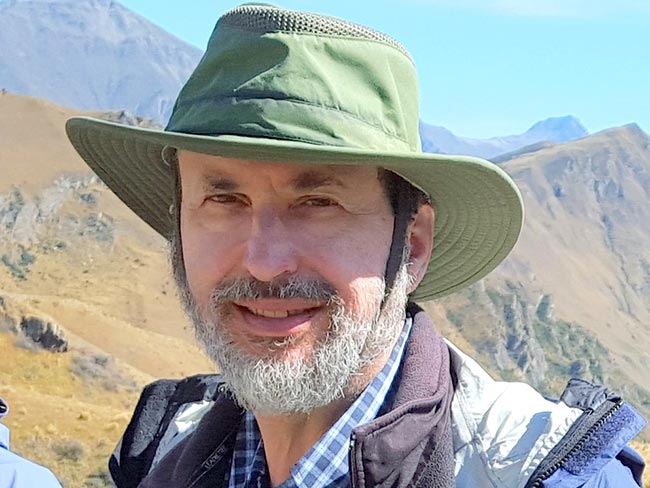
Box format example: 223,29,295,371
428,125,650,422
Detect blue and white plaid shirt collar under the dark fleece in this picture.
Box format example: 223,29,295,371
228,318,412,488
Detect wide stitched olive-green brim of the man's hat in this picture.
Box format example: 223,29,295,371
66,117,523,301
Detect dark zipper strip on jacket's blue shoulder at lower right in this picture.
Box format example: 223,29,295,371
525,398,624,488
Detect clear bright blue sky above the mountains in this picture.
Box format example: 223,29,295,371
120,0,650,137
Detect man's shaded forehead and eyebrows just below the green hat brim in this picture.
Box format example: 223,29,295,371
178,151,381,190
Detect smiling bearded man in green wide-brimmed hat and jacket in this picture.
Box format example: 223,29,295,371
67,5,643,487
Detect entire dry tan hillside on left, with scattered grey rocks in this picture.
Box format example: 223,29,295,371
0,92,212,487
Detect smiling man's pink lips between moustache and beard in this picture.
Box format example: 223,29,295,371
233,300,324,337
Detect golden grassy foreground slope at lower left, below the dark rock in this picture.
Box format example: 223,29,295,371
0,332,140,487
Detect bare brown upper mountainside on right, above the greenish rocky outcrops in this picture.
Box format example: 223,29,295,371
500,125,650,374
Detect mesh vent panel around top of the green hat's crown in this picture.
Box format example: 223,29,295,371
220,5,412,60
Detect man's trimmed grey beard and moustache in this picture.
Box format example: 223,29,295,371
173,264,411,415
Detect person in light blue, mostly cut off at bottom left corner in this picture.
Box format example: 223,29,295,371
0,398,61,488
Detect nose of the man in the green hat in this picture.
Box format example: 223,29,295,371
244,210,298,282
